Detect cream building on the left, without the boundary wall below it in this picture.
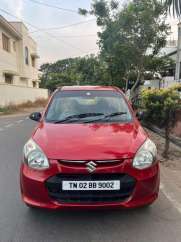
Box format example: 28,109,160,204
0,15,39,88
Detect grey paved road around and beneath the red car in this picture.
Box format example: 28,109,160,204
0,116,181,242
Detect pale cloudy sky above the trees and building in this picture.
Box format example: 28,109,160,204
0,0,177,64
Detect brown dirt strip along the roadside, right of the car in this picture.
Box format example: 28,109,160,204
146,129,181,170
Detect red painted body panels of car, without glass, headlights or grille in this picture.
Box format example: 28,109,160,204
20,86,160,209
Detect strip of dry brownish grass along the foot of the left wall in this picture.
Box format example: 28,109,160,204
0,98,48,114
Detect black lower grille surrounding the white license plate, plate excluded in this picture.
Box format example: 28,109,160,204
46,174,136,203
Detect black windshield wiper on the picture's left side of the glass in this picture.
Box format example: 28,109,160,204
51,113,104,124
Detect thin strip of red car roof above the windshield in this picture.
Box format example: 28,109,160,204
58,86,120,91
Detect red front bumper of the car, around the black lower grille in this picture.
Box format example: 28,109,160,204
20,160,160,209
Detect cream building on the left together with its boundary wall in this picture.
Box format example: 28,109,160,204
0,15,48,107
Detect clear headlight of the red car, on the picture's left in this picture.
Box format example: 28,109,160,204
24,139,50,170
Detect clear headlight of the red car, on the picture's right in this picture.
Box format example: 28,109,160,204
133,139,157,170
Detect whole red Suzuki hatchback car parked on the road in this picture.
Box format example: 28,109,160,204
20,86,160,209
